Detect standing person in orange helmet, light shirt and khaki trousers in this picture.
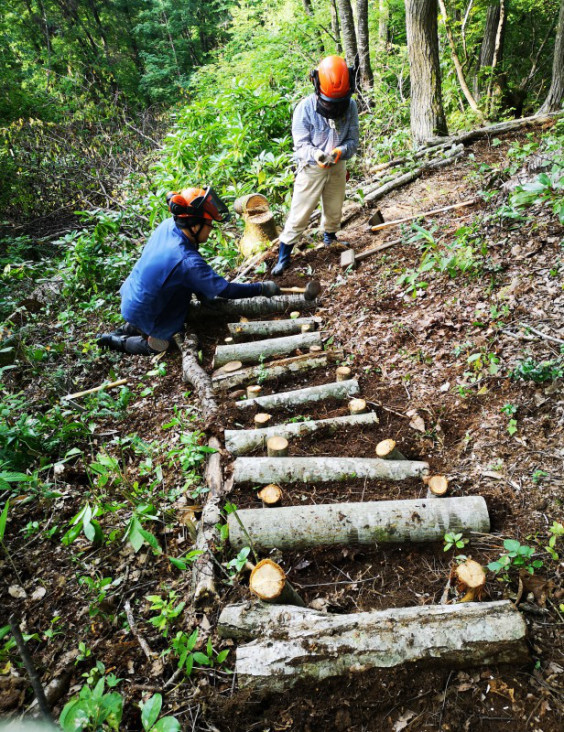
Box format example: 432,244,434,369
272,56,358,276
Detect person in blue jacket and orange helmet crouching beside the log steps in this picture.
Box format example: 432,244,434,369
97,187,280,356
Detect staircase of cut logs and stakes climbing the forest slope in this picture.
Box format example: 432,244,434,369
182,296,527,691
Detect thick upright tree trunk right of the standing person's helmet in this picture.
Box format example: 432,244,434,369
405,0,447,144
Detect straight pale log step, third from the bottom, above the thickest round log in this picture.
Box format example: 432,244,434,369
233,457,429,483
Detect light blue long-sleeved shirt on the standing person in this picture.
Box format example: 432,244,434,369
292,94,358,166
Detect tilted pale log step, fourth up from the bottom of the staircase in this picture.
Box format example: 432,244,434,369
225,412,378,455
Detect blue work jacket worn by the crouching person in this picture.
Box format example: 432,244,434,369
120,219,229,340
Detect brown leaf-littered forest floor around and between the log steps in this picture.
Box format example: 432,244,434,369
0,129,564,732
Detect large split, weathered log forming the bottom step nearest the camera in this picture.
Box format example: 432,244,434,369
218,600,529,691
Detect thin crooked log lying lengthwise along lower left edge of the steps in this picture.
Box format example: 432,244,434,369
191,437,232,610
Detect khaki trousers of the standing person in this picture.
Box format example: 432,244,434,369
280,160,347,244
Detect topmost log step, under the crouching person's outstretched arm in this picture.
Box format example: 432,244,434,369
188,295,318,322
